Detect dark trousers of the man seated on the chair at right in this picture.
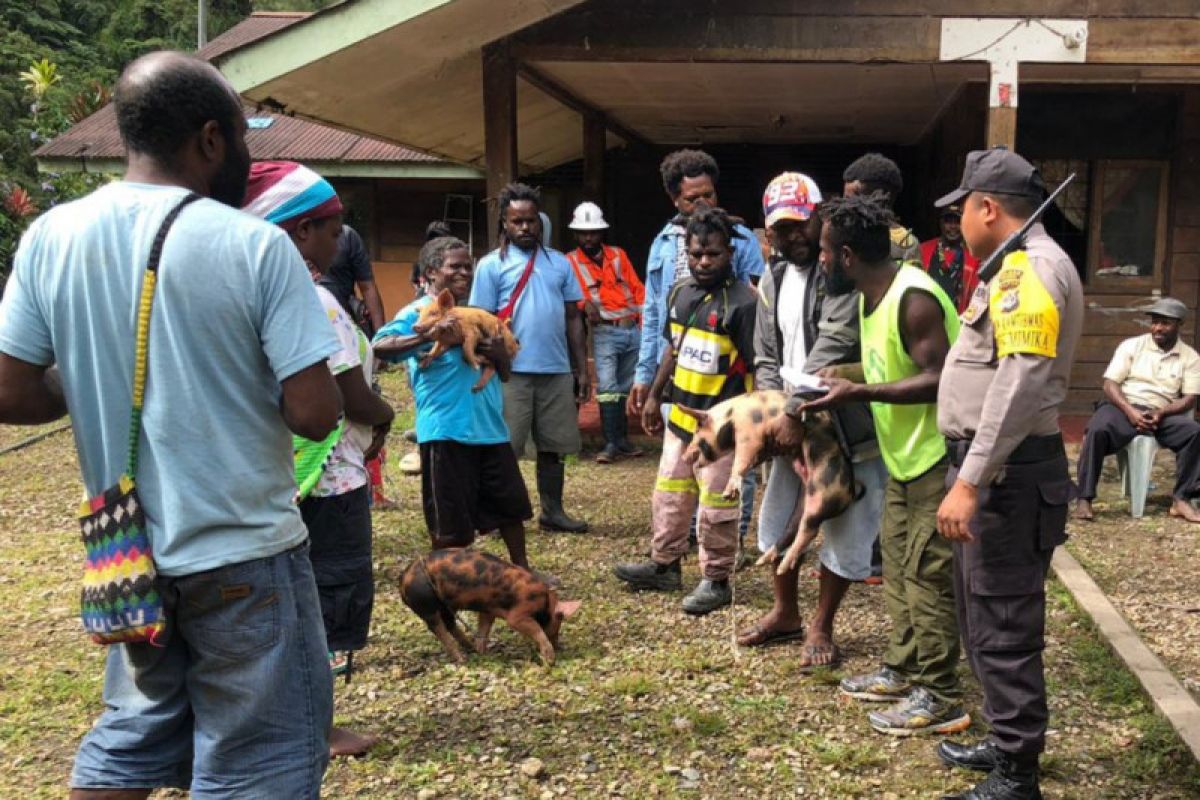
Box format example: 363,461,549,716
1079,401,1200,500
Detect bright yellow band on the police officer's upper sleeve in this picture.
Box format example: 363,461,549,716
984,251,1058,359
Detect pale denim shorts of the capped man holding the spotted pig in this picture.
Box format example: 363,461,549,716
758,457,888,581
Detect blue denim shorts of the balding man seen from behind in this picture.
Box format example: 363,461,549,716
71,545,334,800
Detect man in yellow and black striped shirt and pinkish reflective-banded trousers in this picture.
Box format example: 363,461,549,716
616,209,757,615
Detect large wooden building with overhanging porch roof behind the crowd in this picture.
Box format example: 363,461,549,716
215,0,1200,411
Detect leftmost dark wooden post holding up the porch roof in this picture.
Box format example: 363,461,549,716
484,42,517,247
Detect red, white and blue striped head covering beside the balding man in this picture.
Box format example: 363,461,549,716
242,161,342,230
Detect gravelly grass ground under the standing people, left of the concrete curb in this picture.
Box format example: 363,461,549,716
0,373,1200,800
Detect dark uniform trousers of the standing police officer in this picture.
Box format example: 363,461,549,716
947,435,1072,757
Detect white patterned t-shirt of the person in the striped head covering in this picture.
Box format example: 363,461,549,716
312,285,374,498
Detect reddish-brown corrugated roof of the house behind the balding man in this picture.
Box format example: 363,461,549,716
34,12,440,164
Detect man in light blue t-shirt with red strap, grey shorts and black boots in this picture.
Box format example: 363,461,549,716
470,184,592,533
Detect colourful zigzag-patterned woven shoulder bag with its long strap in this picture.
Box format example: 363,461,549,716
79,193,199,646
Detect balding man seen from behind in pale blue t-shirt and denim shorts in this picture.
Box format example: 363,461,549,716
0,53,341,800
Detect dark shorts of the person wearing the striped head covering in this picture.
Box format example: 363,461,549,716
300,486,374,650
